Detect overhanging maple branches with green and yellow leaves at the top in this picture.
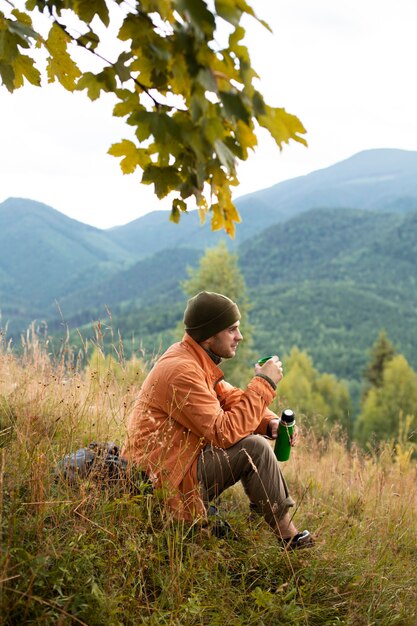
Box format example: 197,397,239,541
0,0,306,236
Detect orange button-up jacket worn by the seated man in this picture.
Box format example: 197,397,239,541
121,333,276,521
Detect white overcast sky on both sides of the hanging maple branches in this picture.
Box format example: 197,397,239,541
0,0,417,228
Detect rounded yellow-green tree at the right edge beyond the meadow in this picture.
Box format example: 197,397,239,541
356,354,417,444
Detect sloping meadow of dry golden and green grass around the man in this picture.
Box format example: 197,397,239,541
0,334,417,626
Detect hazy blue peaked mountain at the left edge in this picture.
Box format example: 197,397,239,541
0,198,132,328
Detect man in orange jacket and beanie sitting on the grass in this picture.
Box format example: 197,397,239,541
122,291,312,548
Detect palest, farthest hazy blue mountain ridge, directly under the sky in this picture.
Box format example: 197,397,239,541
107,148,417,256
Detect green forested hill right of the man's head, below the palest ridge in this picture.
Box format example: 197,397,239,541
239,209,417,378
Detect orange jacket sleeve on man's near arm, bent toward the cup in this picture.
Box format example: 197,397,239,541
167,368,275,448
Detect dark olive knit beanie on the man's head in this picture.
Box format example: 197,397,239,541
184,291,240,342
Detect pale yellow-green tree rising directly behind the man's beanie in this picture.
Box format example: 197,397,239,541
181,241,256,387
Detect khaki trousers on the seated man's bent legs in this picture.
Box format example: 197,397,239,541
197,435,294,528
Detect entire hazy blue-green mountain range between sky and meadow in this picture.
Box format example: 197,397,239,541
0,149,417,378
